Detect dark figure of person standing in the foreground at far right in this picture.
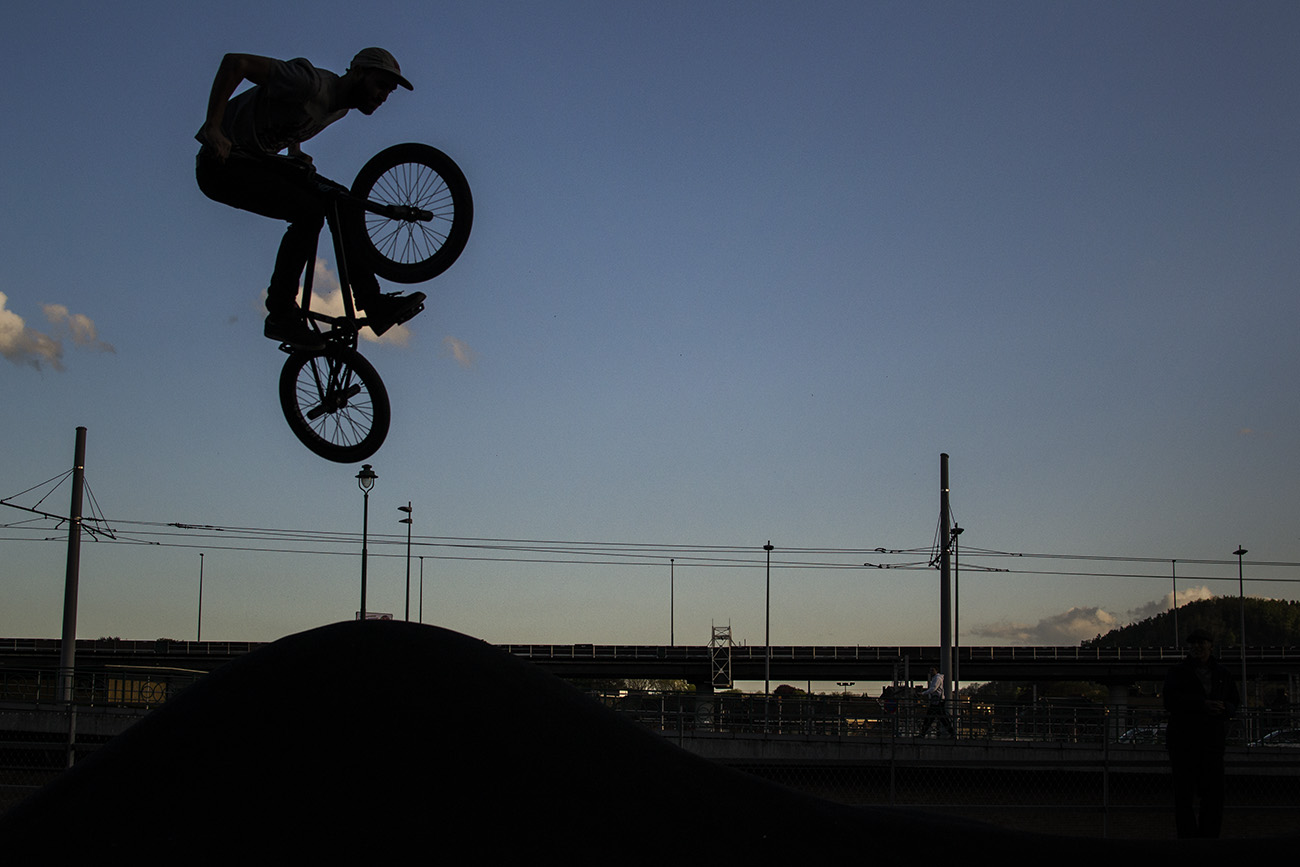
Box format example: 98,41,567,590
1164,629,1238,837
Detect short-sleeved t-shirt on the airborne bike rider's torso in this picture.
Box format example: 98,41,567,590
196,57,347,155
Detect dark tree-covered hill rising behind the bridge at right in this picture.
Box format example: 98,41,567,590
1083,597,1300,647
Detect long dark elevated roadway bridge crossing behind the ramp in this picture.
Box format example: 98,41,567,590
0,638,1300,689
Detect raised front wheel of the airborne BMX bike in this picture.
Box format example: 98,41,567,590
348,142,475,283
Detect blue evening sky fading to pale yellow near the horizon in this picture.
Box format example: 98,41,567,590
0,1,1300,645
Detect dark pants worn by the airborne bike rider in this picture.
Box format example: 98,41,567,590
195,148,380,312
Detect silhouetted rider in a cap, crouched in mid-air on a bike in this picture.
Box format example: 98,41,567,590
195,48,425,350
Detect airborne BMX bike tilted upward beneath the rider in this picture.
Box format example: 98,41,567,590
280,143,473,464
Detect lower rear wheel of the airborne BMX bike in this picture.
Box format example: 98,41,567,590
280,346,393,464
